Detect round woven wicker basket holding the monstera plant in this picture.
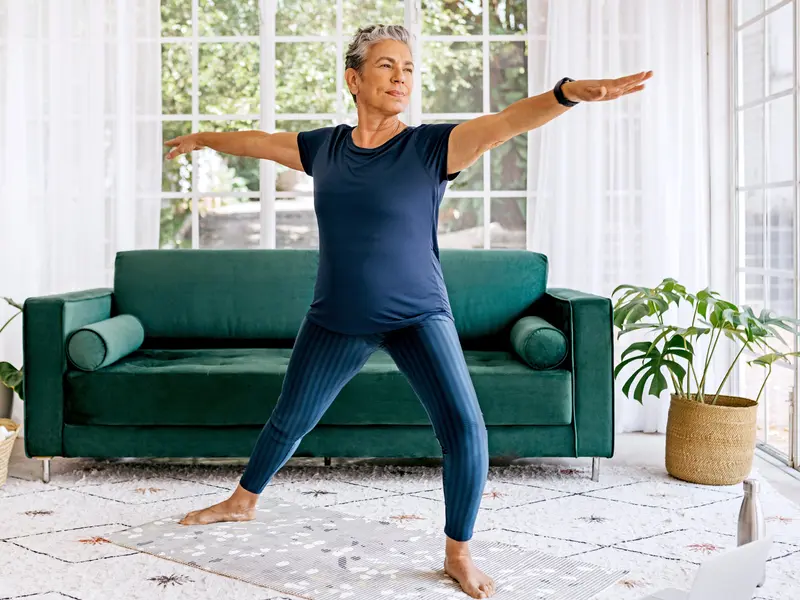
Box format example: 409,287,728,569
666,394,758,485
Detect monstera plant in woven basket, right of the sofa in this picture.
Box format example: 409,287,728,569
612,278,800,485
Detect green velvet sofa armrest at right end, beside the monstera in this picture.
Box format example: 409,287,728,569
532,288,614,457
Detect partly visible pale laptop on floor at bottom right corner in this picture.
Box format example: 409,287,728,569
642,536,772,600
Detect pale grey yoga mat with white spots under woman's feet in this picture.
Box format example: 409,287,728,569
104,498,624,600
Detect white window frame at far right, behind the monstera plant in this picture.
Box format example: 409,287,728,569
729,0,800,468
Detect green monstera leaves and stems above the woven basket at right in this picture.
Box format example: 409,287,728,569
612,278,800,404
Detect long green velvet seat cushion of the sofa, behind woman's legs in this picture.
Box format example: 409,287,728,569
65,348,572,426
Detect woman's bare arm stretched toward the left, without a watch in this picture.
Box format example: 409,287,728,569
164,130,303,171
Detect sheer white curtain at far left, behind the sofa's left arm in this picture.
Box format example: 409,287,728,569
0,0,163,432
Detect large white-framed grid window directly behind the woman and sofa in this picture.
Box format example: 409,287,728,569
156,0,547,248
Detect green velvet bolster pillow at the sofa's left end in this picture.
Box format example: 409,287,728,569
67,315,144,371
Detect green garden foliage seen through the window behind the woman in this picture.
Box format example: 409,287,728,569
161,0,535,246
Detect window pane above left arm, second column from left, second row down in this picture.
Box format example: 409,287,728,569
199,43,260,115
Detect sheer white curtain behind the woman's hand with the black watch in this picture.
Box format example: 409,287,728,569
532,0,709,432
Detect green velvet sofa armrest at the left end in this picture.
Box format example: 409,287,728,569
22,288,113,457
